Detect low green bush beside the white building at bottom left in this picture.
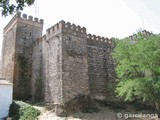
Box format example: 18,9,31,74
9,101,40,120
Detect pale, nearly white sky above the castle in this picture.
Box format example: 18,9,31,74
0,0,160,56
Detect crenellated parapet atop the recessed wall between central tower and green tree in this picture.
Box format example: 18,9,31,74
87,34,112,47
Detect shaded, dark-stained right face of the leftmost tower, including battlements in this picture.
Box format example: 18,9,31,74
14,14,43,99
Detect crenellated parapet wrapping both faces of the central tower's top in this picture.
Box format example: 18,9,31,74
46,20,86,39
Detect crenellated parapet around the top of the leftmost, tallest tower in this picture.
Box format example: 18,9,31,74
3,12,43,33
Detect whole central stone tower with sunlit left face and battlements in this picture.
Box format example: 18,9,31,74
43,21,90,113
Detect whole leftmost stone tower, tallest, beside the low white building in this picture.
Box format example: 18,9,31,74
2,13,43,100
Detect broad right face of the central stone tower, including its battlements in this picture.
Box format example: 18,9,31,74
62,23,90,102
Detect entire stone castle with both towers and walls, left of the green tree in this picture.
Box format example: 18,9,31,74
2,13,115,112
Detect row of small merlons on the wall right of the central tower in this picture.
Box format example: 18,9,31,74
87,34,112,45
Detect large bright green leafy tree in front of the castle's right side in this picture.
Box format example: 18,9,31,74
112,32,160,116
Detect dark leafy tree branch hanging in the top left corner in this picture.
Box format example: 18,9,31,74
0,0,35,16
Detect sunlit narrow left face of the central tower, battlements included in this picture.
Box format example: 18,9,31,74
43,23,63,104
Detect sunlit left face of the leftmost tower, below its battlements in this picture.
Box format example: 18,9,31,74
2,25,17,83
